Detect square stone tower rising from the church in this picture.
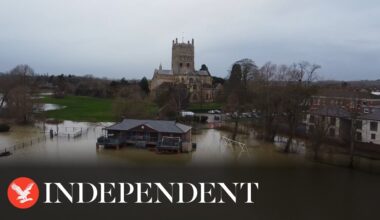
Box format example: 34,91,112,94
172,38,195,75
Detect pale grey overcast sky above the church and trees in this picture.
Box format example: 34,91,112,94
0,0,380,80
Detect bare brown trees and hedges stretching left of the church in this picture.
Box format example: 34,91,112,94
0,65,154,123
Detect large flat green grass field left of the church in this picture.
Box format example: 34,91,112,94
42,96,115,122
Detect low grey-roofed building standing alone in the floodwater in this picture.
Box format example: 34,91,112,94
97,119,192,151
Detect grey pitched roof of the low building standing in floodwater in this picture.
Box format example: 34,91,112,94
106,119,191,134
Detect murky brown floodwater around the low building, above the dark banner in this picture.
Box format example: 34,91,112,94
0,121,380,169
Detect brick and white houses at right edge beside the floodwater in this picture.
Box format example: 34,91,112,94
305,90,380,145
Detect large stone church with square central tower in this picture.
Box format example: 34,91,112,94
150,39,214,103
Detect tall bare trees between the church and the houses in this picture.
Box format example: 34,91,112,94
223,59,321,151
